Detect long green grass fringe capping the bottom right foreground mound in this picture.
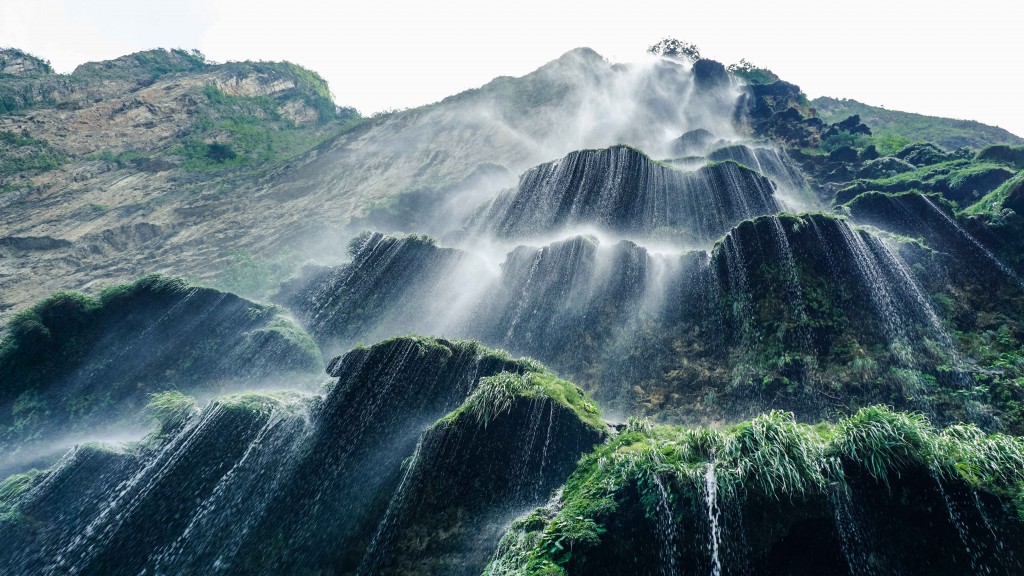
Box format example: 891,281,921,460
488,407,1024,575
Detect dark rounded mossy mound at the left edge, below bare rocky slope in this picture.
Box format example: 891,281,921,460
0,276,323,467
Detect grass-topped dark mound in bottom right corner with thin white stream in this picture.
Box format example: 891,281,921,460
486,408,1024,576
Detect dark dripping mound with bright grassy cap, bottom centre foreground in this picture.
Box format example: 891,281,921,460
360,372,607,575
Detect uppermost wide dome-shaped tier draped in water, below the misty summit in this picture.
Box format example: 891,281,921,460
471,146,779,242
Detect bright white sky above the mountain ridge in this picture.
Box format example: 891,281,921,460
0,0,1024,135
